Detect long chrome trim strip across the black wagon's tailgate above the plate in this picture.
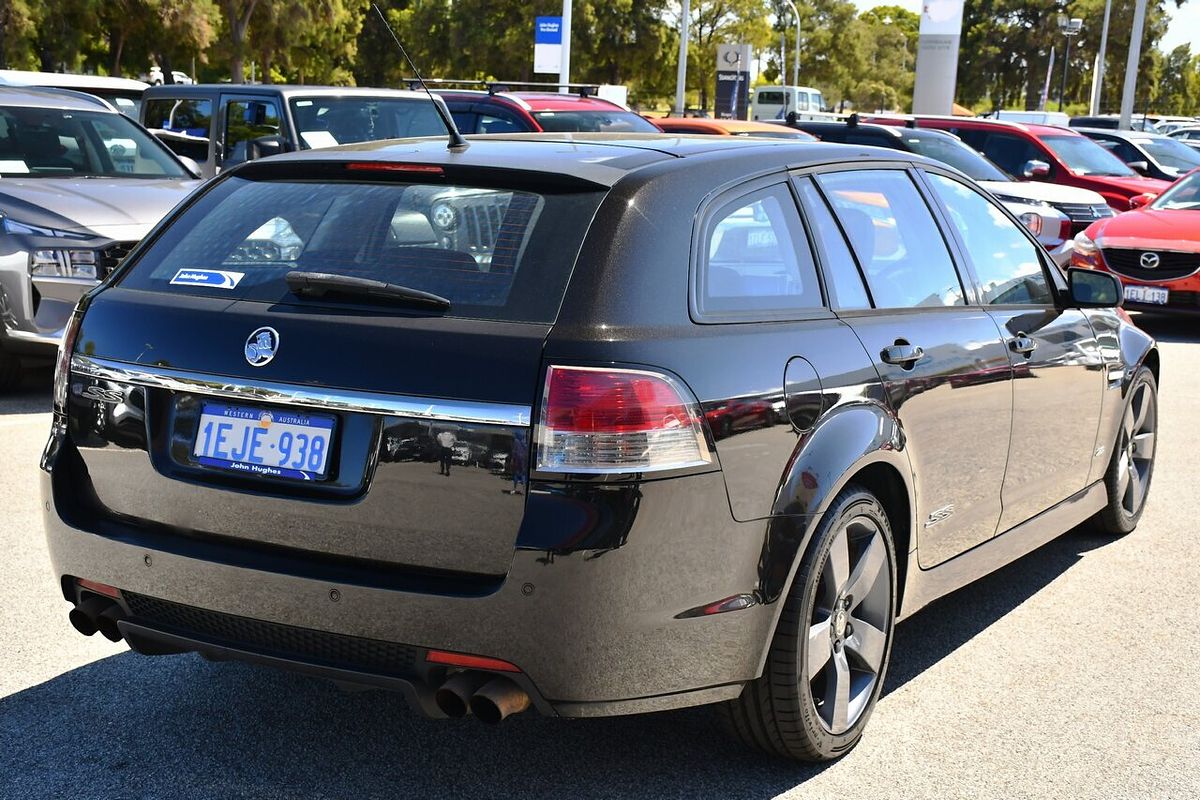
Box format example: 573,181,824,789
71,355,533,427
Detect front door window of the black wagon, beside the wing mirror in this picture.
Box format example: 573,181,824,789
929,174,1054,306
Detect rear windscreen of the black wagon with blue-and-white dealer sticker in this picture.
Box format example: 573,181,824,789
119,178,602,323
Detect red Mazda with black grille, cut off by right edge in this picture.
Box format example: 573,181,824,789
1072,169,1200,312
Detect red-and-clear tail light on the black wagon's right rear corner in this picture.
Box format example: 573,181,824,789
536,367,713,474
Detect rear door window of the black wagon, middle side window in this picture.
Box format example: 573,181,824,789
817,169,965,308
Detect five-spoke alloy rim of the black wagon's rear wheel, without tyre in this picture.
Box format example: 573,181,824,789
803,516,893,734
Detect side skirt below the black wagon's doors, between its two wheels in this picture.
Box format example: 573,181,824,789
898,481,1108,619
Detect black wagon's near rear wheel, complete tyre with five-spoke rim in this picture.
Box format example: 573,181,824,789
720,485,896,762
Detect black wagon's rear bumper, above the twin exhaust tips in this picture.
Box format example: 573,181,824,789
42,450,775,716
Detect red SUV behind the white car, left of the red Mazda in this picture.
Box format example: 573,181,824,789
873,116,1170,211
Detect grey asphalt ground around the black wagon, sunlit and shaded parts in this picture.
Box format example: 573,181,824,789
0,319,1200,800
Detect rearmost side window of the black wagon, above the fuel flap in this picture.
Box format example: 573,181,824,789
697,184,822,318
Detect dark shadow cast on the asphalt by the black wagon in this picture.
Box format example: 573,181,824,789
0,533,1104,800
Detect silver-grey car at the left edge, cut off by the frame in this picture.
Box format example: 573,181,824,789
0,88,199,391
